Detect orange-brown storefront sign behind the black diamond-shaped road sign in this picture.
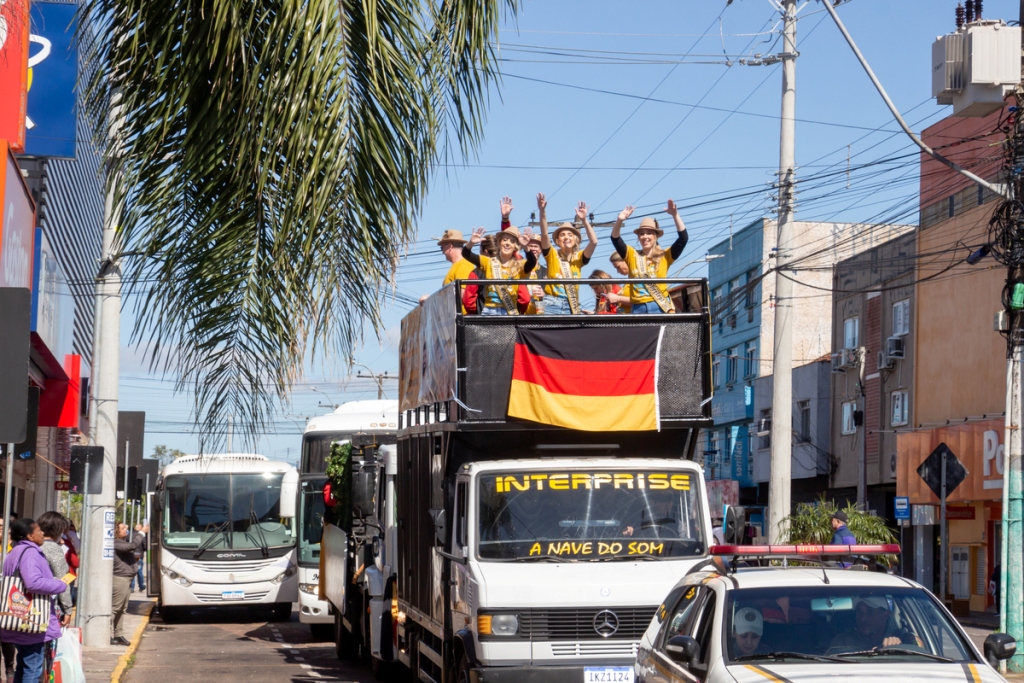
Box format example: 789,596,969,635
896,420,1006,504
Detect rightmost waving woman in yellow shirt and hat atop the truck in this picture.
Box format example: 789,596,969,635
611,200,688,313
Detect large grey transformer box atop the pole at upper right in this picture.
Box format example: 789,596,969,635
932,19,1021,117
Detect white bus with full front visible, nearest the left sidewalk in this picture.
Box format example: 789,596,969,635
147,454,299,622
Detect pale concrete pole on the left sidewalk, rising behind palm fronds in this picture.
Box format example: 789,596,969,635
79,92,121,647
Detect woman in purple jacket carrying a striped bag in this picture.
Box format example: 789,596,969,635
0,517,68,683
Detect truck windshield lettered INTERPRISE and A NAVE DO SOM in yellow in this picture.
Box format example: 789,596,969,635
479,470,706,561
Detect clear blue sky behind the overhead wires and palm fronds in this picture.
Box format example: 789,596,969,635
121,0,1019,460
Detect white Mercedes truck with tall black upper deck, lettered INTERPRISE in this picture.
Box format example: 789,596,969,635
322,280,712,683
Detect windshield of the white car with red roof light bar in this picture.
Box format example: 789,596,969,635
722,586,974,664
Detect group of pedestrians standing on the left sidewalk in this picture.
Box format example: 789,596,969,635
0,511,148,683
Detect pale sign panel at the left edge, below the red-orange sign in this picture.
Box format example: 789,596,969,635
0,144,36,289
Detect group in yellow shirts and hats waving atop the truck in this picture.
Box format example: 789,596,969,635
420,194,687,315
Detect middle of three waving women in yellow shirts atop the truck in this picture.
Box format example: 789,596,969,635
537,193,597,315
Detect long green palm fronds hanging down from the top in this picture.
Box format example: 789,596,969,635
79,0,519,444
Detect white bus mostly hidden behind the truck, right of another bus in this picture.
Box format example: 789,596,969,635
298,400,398,640
